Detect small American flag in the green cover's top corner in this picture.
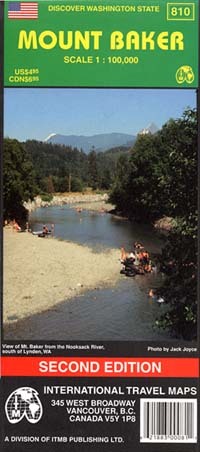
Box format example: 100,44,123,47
8,2,38,19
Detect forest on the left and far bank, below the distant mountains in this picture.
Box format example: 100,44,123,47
3,138,128,221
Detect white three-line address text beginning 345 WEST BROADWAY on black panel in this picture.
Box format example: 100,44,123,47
51,399,136,423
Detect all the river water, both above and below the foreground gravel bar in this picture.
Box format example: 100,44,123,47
6,206,167,340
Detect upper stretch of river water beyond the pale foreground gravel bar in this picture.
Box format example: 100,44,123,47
29,206,163,253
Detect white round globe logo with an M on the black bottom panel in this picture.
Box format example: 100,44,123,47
5,387,43,424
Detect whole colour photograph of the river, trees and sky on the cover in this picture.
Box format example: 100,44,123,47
3,88,197,341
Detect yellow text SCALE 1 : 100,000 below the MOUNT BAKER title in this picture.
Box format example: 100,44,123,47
64,55,139,65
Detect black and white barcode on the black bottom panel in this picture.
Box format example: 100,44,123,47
140,399,197,443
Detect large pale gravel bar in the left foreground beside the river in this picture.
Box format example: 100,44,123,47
3,228,120,323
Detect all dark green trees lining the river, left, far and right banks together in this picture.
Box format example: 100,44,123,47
3,109,198,339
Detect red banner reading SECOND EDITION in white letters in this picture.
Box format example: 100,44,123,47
1,357,199,378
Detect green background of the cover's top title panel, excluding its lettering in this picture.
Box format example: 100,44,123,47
4,0,198,88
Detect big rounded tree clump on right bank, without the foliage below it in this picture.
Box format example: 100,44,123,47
111,110,197,222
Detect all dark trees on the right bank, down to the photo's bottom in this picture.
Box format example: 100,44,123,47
110,110,198,339
